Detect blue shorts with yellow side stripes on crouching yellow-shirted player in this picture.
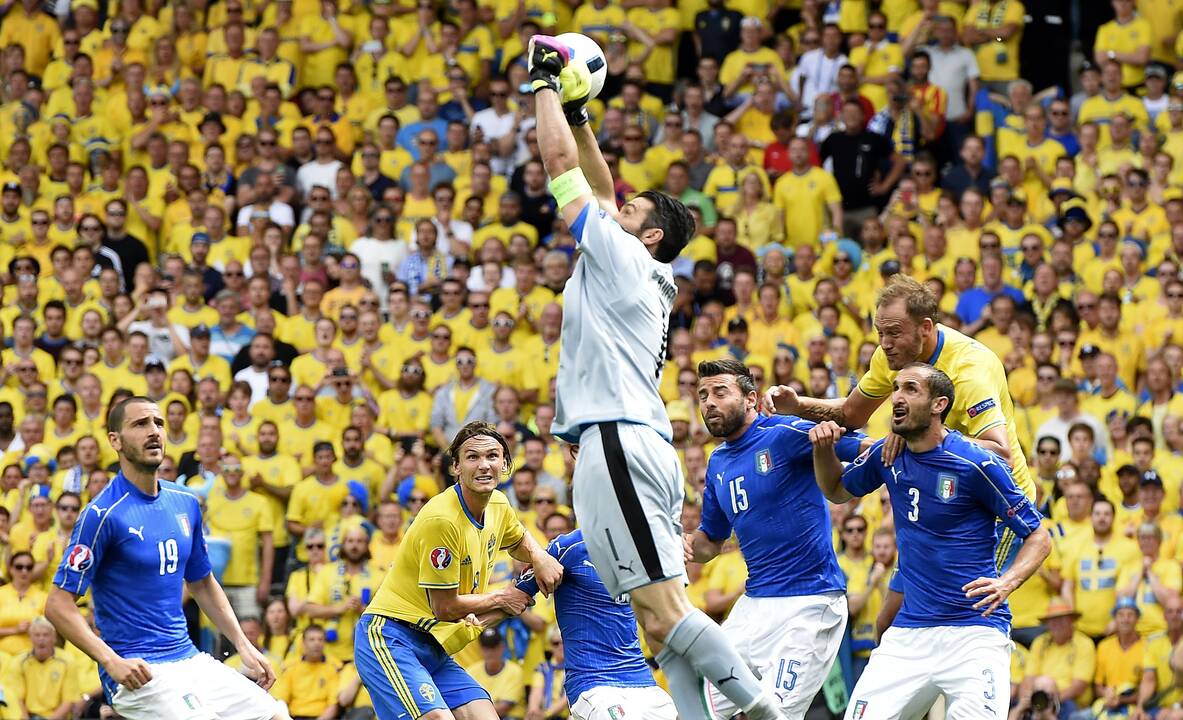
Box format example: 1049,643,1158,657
354,614,490,720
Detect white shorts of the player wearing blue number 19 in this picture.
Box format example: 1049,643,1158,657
111,653,284,720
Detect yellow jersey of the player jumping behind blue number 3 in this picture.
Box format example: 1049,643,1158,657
859,324,1035,500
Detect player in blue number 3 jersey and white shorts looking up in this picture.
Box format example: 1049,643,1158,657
809,363,1052,720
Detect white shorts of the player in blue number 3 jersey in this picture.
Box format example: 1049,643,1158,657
846,625,1011,720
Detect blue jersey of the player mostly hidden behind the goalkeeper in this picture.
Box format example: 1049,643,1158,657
517,530,657,703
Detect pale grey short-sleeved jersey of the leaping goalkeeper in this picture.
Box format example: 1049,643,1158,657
554,203,678,442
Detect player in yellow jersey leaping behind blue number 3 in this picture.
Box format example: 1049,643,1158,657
764,274,1035,616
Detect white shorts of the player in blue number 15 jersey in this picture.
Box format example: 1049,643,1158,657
706,592,849,720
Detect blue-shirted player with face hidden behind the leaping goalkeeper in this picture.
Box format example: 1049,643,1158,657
508,530,678,720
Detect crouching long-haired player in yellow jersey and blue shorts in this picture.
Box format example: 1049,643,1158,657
355,422,563,720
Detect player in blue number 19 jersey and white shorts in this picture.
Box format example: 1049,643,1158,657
45,397,287,720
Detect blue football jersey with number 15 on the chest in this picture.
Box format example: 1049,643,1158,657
699,415,861,597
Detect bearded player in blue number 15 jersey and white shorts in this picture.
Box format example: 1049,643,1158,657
685,359,870,719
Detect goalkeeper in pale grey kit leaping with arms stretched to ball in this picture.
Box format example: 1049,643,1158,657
528,35,780,720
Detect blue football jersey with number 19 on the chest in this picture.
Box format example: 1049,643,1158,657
53,472,211,692
